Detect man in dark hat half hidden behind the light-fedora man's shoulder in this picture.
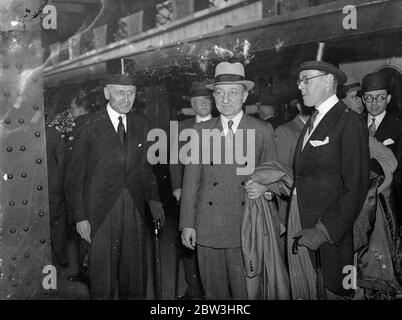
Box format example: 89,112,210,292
169,81,212,299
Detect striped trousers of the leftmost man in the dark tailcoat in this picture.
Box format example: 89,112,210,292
89,189,147,299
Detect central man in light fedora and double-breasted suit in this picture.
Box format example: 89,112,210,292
180,62,277,299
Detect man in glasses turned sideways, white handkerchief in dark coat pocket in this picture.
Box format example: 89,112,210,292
288,61,369,299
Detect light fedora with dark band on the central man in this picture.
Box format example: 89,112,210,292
207,62,254,91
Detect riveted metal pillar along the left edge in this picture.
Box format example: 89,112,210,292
0,0,50,299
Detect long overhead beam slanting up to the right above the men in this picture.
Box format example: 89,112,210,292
45,0,402,84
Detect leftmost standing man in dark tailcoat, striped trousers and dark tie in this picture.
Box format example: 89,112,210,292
66,75,164,299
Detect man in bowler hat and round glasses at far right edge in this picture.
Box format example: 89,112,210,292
362,72,402,225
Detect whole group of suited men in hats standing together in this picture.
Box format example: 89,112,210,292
47,61,402,299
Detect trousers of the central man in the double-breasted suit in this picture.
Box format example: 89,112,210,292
197,245,247,300
